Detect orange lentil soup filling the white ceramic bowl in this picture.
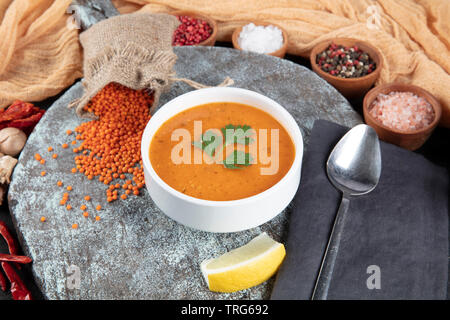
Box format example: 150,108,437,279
150,102,295,201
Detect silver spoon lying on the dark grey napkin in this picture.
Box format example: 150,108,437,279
312,124,381,300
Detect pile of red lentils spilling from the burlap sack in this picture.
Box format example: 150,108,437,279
73,83,153,202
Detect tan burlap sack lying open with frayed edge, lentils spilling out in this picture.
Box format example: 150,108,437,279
69,13,179,118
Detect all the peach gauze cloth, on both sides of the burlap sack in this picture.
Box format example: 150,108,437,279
0,0,450,127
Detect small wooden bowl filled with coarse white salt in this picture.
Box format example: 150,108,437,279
231,22,288,58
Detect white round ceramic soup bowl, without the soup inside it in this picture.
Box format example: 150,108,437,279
141,87,303,232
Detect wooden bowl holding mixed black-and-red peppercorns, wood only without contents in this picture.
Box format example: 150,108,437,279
309,38,383,98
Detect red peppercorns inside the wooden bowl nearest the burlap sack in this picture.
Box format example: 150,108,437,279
172,16,212,46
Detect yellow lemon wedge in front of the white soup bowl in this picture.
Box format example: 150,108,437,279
200,232,286,292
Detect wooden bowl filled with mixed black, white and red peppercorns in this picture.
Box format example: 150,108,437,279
309,38,383,98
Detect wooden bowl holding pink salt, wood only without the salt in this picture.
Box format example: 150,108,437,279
363,83,442,150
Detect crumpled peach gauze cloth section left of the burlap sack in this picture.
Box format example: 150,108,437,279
0,0,82,109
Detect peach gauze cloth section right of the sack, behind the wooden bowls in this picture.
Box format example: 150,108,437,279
113,0,450,127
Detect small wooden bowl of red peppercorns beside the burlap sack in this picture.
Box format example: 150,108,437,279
170,10,217,46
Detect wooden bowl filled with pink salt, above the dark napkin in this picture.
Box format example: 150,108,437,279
363,83,442,150
